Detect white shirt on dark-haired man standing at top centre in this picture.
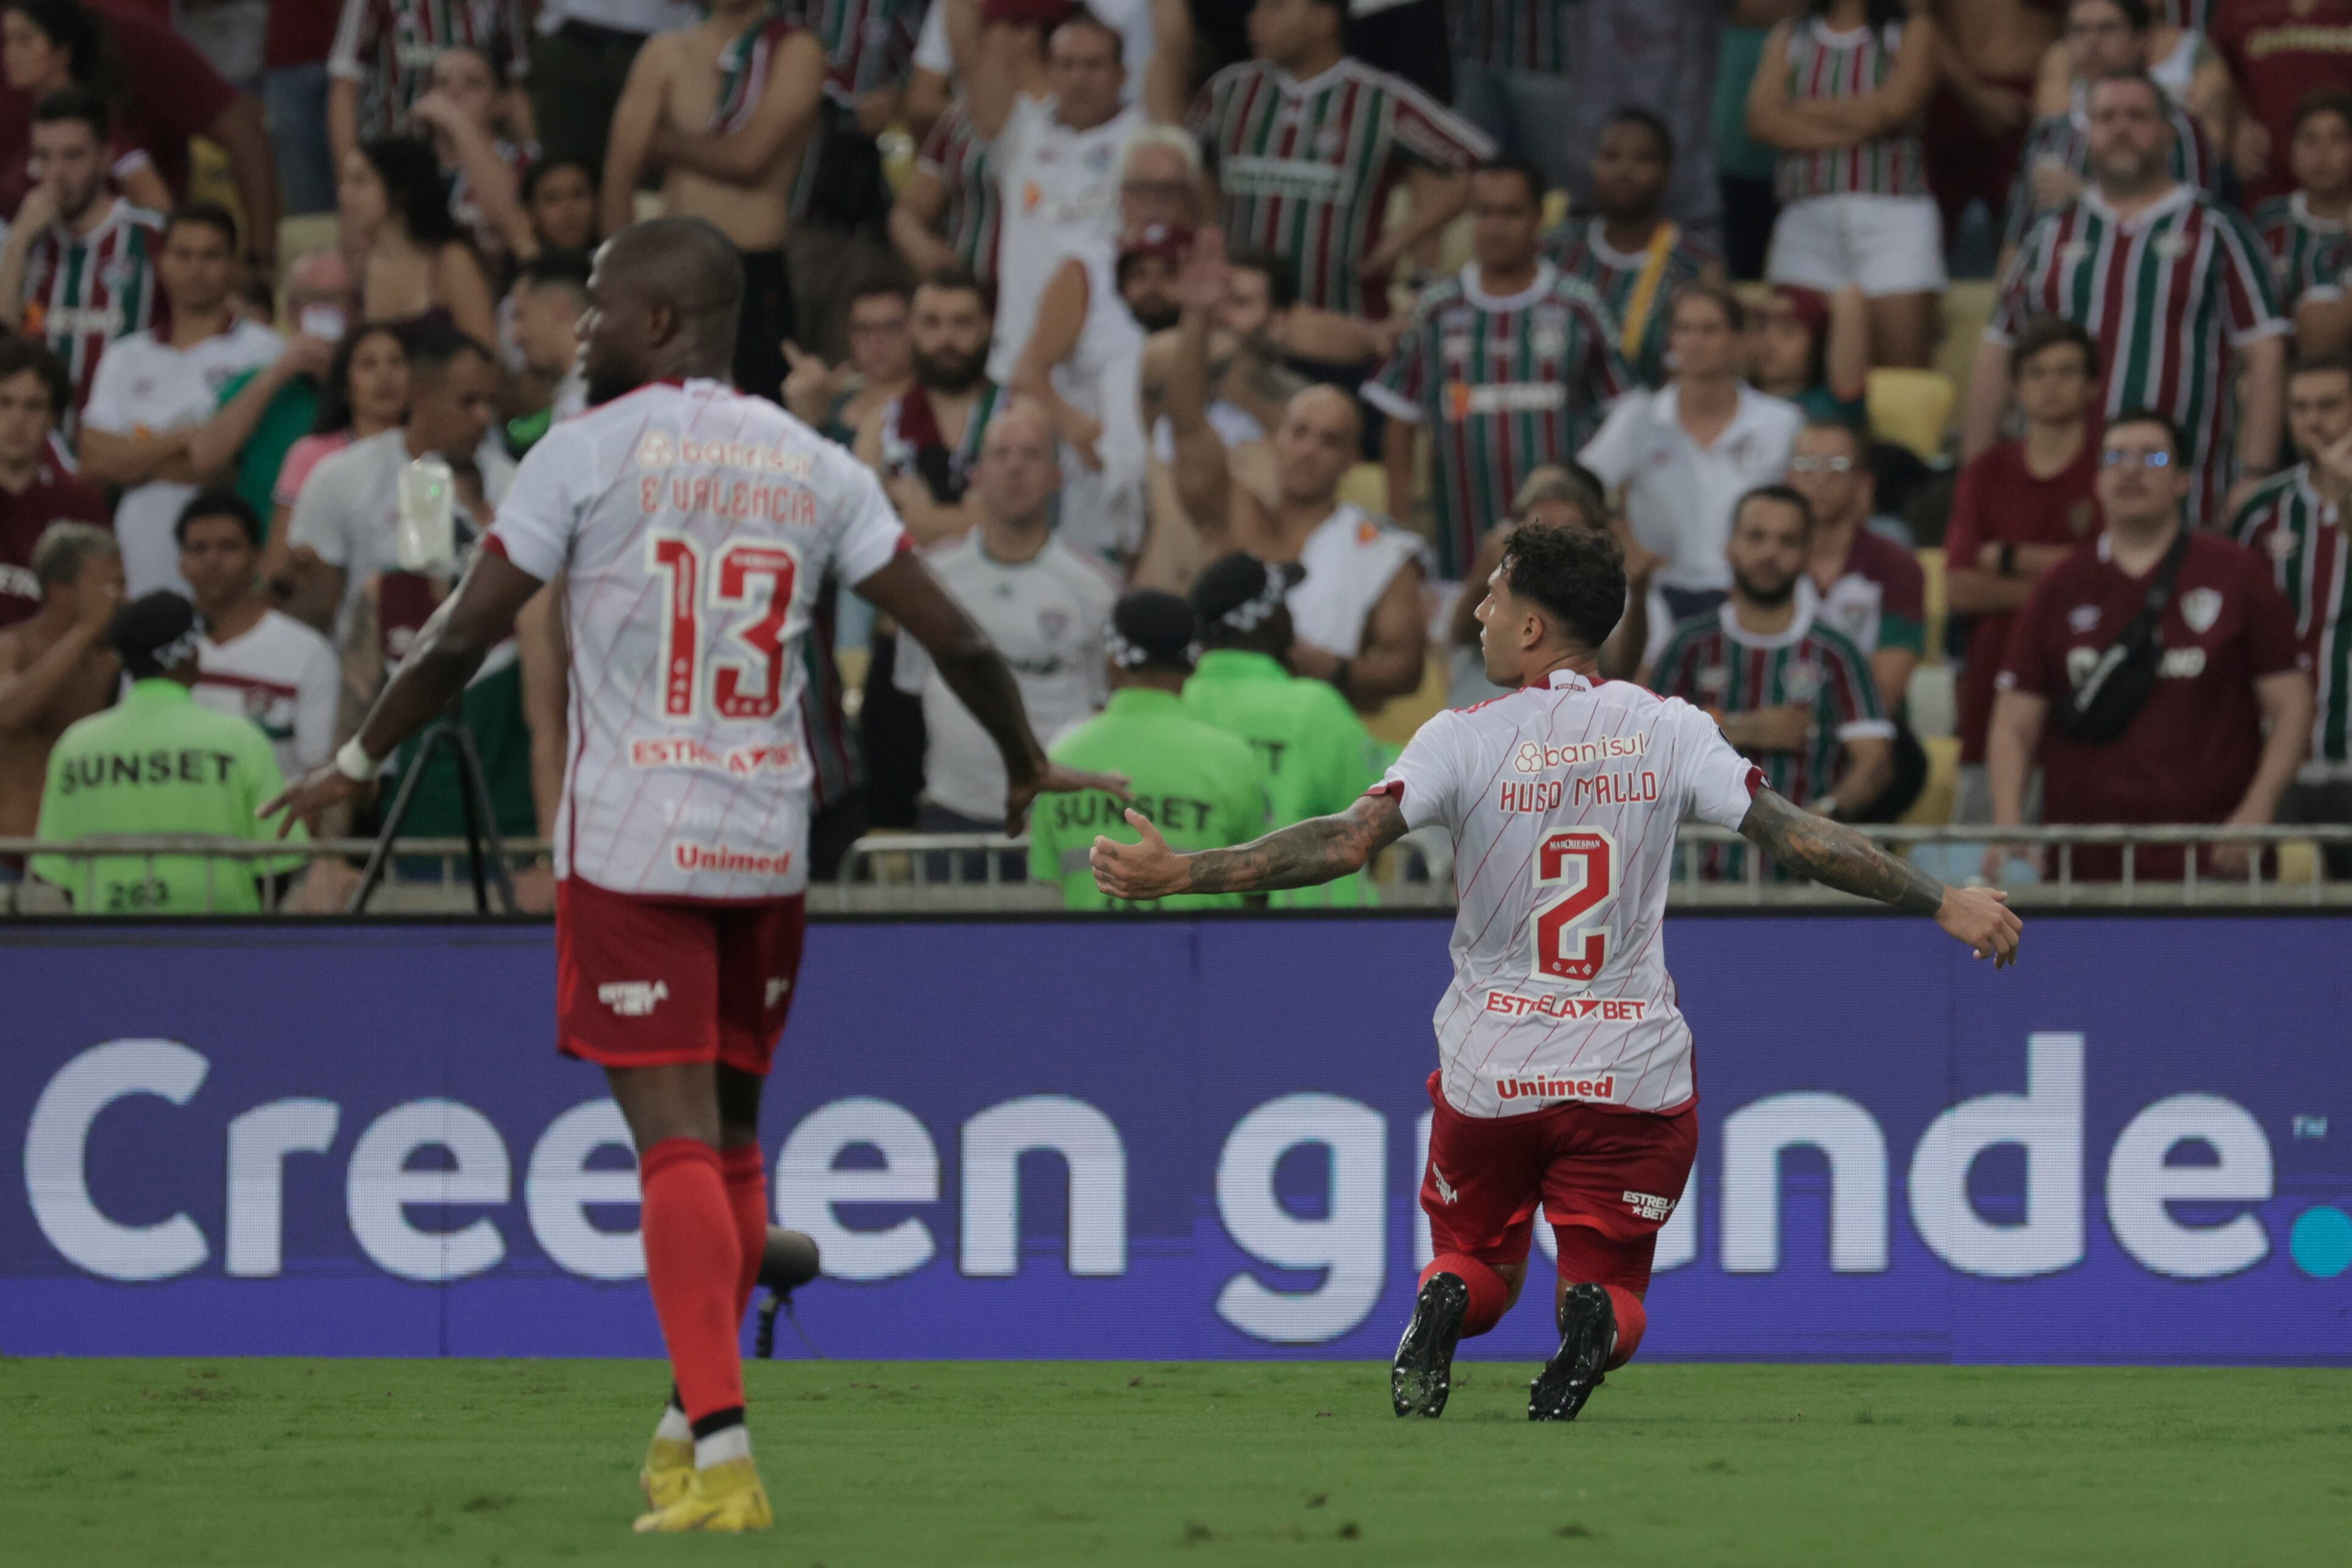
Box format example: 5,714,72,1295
988,96,1143,385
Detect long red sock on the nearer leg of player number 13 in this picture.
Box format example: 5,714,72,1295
638,1138,743,1429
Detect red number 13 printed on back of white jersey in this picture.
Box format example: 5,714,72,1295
644,531,800,719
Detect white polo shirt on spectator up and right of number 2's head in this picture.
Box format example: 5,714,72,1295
1576,383,1804,590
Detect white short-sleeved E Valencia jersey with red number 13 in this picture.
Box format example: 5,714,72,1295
491,381,906,901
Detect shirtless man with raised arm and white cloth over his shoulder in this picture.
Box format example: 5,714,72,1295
1167,244,1428,712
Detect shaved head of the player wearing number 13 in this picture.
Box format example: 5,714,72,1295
581,219,743,402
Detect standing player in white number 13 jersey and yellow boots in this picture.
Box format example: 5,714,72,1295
264,219,1119,1533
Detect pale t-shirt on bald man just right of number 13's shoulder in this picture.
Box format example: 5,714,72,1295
894,529,1119,823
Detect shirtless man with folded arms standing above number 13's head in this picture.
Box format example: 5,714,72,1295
602,0,826,397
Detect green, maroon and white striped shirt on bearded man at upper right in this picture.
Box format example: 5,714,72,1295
1985,186,2286,519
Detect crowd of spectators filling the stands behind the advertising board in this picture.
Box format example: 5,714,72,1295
0,0,2352,910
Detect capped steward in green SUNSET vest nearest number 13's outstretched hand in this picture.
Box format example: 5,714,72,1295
1030,588,1268,910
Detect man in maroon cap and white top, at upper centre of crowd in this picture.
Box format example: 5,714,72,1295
1012,211,1192,576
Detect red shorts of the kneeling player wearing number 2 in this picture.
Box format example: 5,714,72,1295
1421,1072,1698,1295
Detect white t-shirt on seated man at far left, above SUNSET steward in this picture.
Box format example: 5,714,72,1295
82,320,284,599
